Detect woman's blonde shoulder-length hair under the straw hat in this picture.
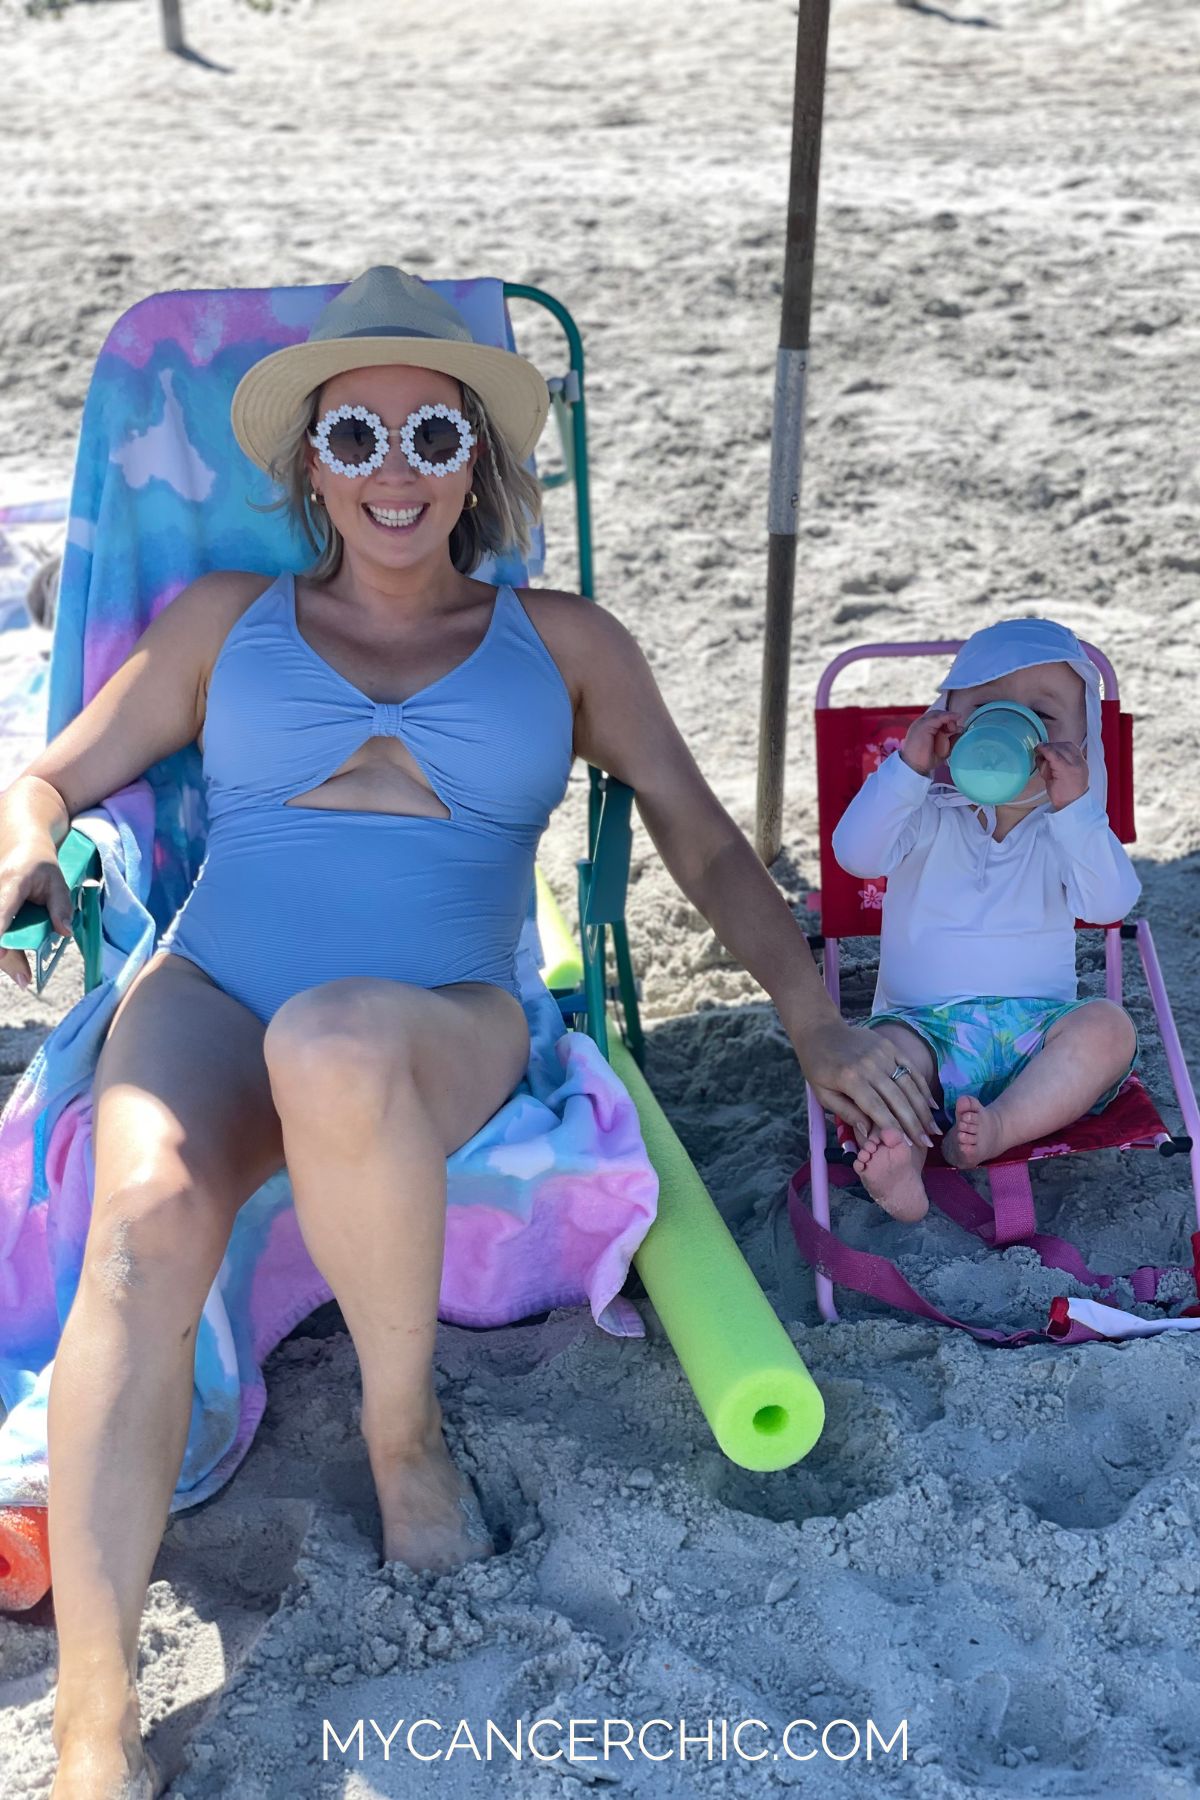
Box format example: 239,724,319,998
260,382,542,581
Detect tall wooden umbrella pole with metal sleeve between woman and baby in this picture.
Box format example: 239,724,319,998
756,0,829,866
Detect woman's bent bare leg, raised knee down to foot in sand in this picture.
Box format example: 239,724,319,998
264,977,529,1570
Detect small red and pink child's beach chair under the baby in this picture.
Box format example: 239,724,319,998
786,641,1200,1345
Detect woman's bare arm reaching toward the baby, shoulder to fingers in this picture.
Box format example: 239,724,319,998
576,603,932,1141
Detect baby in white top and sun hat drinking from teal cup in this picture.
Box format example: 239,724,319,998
833,619,1141,1219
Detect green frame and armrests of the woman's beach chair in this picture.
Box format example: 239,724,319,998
0,281,644,1067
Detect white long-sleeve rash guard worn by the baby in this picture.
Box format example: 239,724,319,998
833,751,1142,1012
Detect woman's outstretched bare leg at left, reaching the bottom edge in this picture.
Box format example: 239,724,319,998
49,956,282,1800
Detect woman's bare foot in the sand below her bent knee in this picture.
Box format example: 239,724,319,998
374,1431,495,1575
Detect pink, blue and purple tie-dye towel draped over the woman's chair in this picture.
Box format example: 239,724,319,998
0,281,658,1510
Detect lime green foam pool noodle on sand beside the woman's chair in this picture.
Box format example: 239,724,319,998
608,1031,826,1469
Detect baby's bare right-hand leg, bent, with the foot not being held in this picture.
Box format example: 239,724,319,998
943,1001,1137,1168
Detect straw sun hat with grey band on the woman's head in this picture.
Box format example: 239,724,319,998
230,266,551,470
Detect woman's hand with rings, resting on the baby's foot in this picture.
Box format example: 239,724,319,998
795,1019,941,1150
